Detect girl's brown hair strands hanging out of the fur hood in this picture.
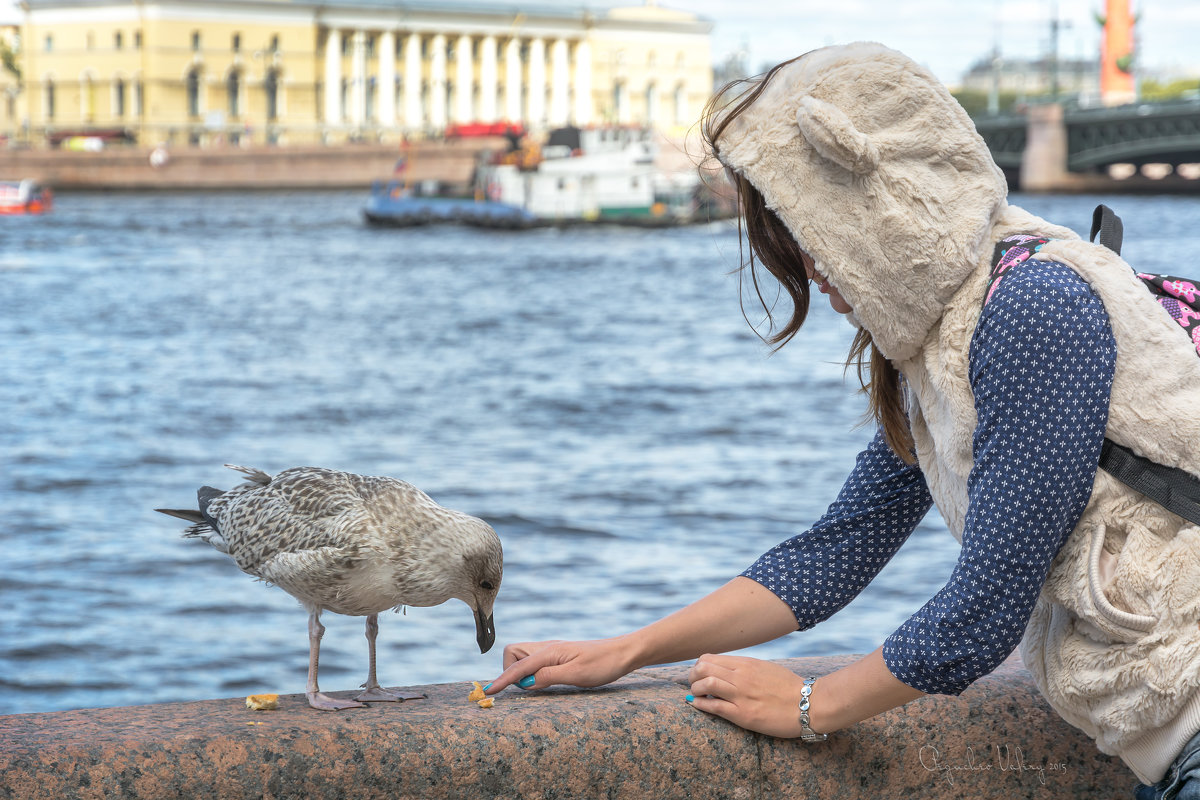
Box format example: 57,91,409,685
701,61,916,464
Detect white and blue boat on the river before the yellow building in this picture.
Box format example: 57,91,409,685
364,127,709,229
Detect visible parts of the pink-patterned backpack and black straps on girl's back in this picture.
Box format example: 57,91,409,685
983,205,1200,525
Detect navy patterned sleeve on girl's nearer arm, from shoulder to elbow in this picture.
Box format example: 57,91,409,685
883,261,1116,694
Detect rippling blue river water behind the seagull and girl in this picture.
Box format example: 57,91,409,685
0,192,1200,712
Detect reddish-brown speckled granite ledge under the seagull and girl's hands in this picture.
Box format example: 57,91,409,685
0,656,1136,800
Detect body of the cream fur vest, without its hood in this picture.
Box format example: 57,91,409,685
899,206,1200,783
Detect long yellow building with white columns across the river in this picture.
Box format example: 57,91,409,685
0,0,713,145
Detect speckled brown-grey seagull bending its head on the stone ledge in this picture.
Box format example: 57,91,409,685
155,464,504,711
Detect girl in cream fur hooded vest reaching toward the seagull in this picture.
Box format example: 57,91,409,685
487,44,1200,798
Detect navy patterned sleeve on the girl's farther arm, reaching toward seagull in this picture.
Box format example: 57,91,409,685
742,424,932,631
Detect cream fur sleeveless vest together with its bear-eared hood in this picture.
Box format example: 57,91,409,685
714,42,1200,783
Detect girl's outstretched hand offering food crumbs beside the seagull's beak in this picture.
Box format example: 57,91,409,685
485,637,634,694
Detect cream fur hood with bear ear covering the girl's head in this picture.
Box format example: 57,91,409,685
716,43,1008,361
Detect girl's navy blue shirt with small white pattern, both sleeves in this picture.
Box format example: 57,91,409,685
743,261,1116,694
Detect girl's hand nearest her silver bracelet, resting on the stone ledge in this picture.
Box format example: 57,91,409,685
688,655,806,738
